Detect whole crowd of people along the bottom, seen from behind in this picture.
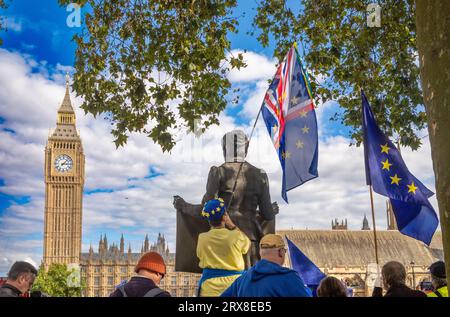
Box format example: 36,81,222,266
0,199,448,297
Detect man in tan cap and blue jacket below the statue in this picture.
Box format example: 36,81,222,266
221,234,312,297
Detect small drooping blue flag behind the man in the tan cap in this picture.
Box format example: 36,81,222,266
286,237,326,290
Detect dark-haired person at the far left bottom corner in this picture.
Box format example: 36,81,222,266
0,261,37,297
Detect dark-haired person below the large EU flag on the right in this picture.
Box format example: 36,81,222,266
372,261,427,297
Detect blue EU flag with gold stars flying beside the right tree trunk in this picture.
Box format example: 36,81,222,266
361,90,439,245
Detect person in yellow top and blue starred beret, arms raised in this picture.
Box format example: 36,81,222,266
197,198,250,297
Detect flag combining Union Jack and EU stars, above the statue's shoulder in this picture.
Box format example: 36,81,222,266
261,46,319,202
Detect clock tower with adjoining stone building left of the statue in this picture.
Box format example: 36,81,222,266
42,78,199,296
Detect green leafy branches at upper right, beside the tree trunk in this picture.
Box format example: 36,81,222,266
253,0,426,149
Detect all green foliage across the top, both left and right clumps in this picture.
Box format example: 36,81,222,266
59,0,426,151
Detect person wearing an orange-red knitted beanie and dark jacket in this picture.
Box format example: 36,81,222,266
109,252,170,297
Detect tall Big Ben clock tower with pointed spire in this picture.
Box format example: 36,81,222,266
43,76,84,268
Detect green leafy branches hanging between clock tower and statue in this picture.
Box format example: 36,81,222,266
59,0,245,151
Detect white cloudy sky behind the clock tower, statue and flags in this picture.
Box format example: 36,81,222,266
0,50,436,275
